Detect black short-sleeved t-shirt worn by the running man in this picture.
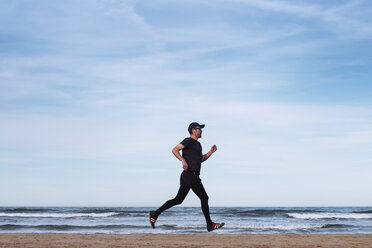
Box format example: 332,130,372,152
181,137,203,175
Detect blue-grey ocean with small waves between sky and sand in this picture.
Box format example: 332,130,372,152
0,207,372,234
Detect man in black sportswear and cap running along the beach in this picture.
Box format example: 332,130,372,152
149,122,225,232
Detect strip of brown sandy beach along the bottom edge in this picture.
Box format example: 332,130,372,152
0,234,372,248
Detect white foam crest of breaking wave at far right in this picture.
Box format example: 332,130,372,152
288,213,372,219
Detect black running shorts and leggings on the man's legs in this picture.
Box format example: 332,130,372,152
154,171,213,226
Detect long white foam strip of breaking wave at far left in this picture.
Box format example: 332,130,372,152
0,212,120,218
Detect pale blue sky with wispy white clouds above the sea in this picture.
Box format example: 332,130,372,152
0,0,372,207
